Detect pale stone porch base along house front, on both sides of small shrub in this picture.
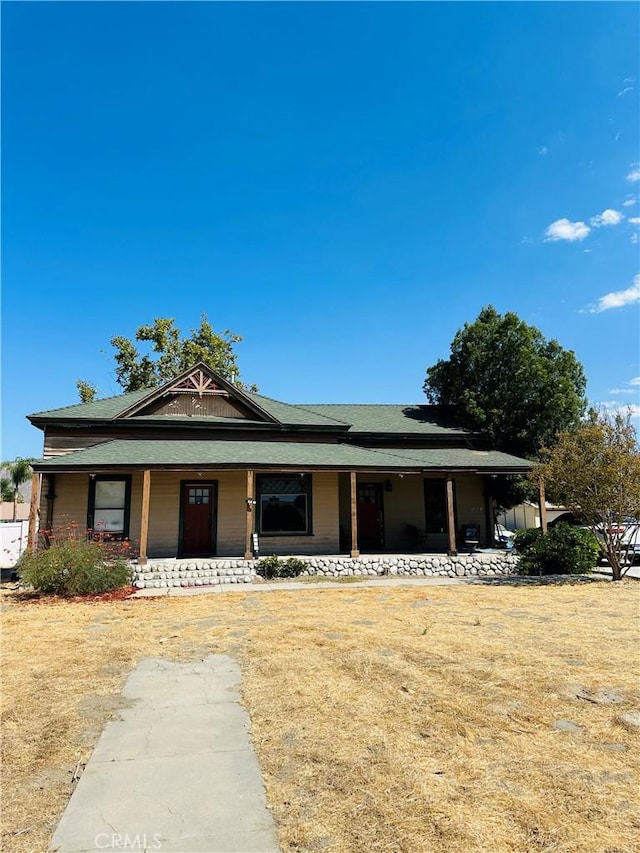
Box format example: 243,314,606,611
132,551,518,589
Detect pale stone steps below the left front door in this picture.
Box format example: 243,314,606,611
132,560,256,589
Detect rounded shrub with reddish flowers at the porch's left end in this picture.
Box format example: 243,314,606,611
16,538,131,595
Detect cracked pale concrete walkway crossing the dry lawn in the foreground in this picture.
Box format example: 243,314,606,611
52,655,280,853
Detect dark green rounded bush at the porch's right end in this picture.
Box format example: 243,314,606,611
515,523,600,575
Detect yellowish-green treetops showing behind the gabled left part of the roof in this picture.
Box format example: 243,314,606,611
76,314,257,403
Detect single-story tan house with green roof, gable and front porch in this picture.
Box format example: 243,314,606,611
23,364,532,563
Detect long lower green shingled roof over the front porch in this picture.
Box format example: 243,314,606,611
34,439,531,471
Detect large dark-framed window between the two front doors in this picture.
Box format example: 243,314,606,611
256,474,312,536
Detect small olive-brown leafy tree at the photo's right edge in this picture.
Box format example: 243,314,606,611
539,411,640,580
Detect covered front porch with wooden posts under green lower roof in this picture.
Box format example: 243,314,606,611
30,440,544,565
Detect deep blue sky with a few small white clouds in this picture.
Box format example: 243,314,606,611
2,2,640,459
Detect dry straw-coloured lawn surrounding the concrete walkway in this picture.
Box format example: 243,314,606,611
2,581,640,853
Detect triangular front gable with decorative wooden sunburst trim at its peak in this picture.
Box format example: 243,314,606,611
114,362,280,424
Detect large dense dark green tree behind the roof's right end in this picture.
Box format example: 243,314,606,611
423,306,587,458
